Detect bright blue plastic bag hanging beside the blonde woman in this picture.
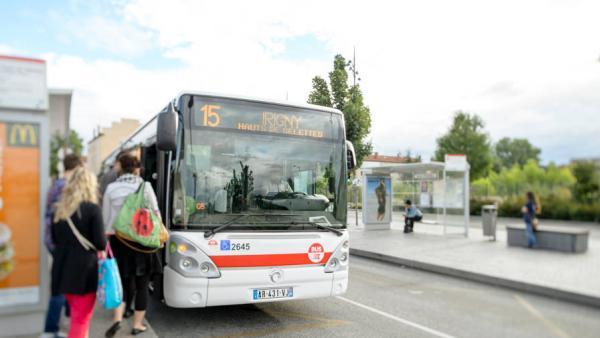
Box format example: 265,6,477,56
97,245,123,310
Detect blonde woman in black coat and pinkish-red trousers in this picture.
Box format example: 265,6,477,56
52,167,106,338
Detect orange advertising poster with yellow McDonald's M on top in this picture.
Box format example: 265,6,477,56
0,121,41,307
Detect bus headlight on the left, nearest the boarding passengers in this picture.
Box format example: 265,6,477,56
167,235,221,278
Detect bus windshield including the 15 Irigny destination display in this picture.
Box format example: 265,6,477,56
172,96,346,230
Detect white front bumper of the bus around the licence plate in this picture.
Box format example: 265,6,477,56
164,266,348,308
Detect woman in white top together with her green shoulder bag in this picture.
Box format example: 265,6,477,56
102,153,166,337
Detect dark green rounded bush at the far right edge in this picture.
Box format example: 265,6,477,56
572,161,600,204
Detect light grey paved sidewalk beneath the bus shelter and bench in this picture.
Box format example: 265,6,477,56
349,215,600,307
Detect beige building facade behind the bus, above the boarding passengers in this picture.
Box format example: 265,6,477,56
87,119,141,174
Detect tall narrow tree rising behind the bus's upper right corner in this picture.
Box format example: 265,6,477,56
308,55,373,167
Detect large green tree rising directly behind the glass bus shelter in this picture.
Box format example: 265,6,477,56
434,111,492,181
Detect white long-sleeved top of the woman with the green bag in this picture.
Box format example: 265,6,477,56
102,174,160,235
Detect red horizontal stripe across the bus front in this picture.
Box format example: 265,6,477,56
210,252,331,268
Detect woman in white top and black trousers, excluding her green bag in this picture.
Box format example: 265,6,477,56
102,153,162,338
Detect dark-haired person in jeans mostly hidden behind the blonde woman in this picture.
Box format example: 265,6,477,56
41,154,83,338
